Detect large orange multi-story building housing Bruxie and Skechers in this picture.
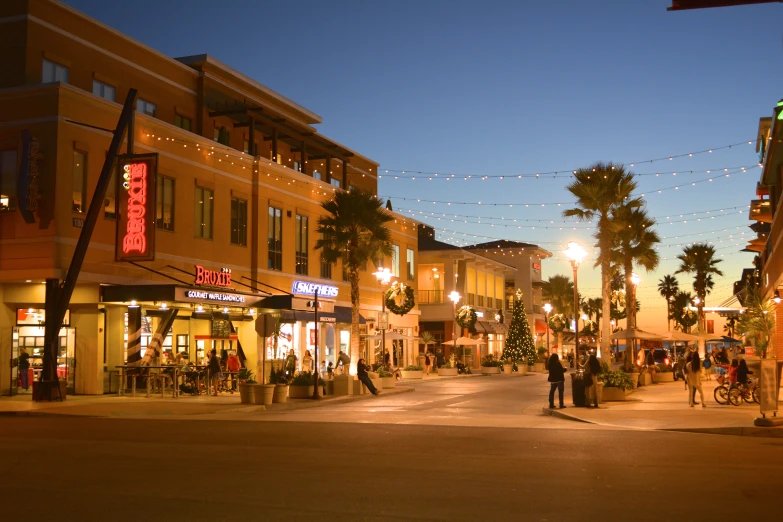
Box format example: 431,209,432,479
0,0,418,394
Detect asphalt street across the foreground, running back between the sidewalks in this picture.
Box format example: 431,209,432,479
0,376,783,521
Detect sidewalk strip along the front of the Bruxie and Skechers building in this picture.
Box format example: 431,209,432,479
0,385,413,418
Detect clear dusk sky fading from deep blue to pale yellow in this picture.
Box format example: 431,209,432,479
66,0,783,332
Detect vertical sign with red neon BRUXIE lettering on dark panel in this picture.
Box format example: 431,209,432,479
115,154,158,261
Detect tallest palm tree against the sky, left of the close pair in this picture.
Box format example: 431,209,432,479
563,163,643,361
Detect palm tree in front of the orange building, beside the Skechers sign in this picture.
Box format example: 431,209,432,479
315,189,393,368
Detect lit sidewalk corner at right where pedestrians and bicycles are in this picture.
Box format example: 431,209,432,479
544,380,783,437
